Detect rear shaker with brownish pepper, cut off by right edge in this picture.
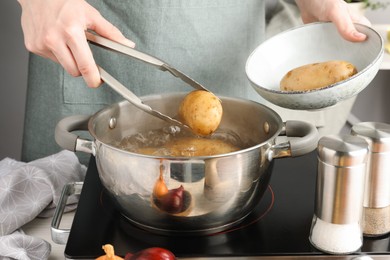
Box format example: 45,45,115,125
351,122,390,237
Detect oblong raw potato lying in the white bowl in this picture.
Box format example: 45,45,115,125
280,60,357,91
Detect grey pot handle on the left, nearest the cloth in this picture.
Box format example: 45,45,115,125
54,115,93,154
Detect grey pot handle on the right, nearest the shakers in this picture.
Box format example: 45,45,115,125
272,120,319,158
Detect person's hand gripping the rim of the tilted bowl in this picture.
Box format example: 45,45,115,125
296,0,371,42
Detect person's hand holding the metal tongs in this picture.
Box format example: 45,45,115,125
18,0,134,87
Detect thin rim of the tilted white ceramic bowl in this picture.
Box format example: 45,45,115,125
245,22,384,96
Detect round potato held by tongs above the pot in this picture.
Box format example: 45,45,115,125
179,90,222,136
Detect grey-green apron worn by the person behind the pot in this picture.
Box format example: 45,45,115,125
22,0,265,161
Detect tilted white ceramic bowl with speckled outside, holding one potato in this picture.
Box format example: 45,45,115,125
245,23,384,110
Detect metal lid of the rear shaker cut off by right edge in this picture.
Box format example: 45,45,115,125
351,122,390,153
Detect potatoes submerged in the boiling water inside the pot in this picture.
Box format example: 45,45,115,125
137,137,240,157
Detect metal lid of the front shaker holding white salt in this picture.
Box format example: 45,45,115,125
317,135,368,167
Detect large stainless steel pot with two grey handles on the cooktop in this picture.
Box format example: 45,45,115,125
55,94,318,234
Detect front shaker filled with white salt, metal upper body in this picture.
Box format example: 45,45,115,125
309,135,368,254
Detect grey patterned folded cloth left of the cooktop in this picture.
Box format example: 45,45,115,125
0,151,86,259
